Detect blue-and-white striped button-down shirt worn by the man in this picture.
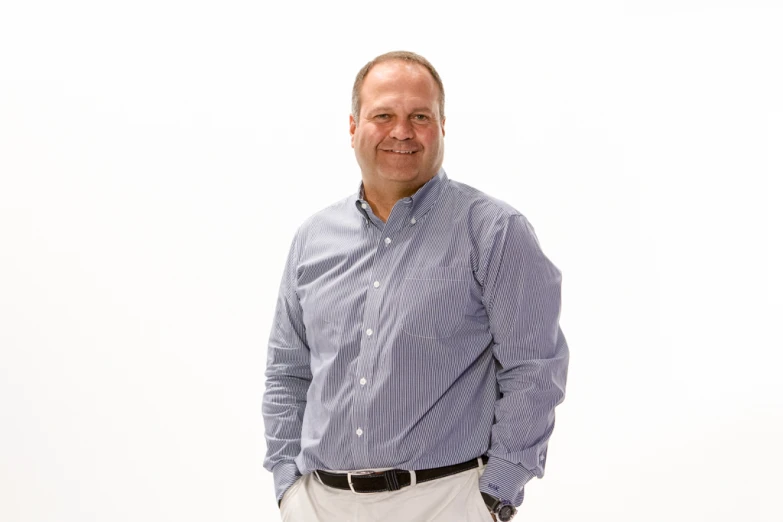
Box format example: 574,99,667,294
263,169,568,506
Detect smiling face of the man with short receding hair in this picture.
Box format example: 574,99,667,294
350,60,446,187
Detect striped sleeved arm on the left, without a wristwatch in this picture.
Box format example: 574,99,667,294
262,233,312,503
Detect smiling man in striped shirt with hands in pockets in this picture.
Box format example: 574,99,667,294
263,52,568,522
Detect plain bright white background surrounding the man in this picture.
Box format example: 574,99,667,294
0,0,783,522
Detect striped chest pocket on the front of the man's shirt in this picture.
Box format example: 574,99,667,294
397,267,472,339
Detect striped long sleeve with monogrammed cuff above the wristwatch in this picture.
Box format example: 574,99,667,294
479,215,569,506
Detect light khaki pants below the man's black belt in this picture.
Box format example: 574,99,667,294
280,466,492,522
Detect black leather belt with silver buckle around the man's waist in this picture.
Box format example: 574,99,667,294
315,455,489,493
